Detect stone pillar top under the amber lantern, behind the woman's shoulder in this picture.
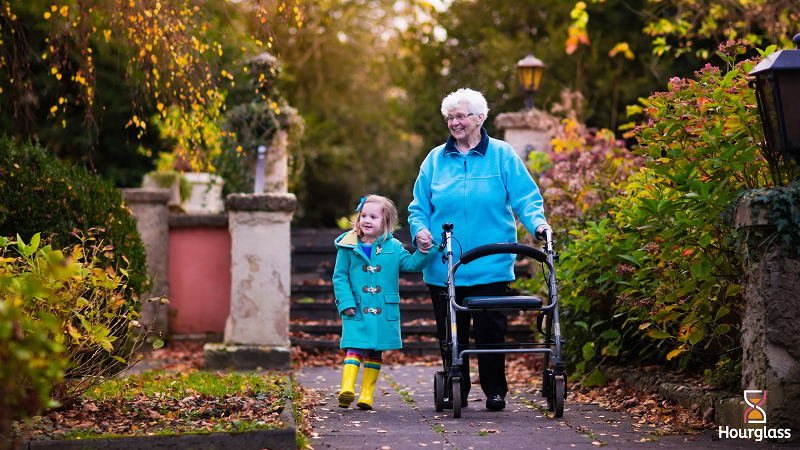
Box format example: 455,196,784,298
495,109,561,161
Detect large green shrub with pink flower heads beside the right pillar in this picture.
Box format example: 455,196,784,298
561,43,787,388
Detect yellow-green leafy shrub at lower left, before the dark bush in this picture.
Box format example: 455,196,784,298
0,229,159,403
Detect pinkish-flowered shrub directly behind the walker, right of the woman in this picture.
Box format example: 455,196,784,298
516,120,643,380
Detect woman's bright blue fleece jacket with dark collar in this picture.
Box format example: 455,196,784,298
408,128,547,286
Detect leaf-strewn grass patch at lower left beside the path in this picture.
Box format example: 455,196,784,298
14,370,294,440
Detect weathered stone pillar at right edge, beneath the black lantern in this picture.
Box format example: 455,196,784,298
735,197,800,443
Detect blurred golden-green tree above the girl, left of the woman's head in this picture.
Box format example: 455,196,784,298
274,0,428,226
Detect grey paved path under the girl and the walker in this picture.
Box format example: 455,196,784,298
295,366,800,450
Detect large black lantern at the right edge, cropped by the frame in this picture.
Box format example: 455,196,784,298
749,34,800,161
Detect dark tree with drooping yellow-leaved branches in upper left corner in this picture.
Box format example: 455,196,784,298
0,0,302,185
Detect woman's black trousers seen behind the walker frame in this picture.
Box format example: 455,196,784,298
428,281,508,398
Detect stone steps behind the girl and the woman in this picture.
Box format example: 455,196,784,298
290,228,534,354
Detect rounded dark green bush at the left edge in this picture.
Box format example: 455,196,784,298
0,136,149,294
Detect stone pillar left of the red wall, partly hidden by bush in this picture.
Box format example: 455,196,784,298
122,189,171,335
